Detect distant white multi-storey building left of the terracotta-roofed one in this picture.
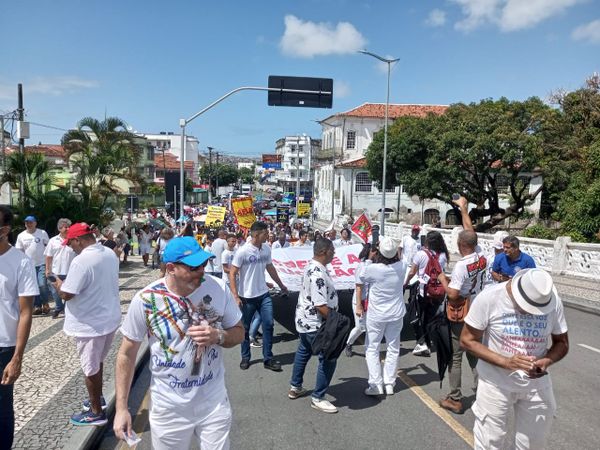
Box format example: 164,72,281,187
271,135,320,194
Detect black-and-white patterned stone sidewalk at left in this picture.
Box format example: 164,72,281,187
13,256,159,450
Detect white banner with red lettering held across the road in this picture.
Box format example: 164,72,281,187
267,244,363,291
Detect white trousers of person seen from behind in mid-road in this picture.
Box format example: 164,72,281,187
365,314,402,386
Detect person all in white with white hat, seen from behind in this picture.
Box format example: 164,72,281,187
359,236,406,395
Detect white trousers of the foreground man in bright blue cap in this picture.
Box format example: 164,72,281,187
150,396,231,450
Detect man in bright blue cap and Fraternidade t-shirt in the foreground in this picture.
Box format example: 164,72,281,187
114,236,244,450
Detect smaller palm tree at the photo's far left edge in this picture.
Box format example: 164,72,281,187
0,152,56,209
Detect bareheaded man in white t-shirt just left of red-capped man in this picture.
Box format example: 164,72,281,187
44,218,75,319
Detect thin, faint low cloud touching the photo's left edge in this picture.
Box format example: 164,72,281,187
0,75,99,99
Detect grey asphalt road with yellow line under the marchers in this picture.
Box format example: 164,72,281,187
99,297,600,450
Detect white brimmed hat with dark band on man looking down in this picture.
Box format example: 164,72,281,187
510,269,557,315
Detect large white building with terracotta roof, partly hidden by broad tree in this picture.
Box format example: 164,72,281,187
314,103,541,225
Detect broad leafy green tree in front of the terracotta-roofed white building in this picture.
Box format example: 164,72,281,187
366,97,561,231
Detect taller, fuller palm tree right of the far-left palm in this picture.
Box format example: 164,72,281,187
62,117,142,211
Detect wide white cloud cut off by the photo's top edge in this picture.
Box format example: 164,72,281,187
451,0,585,32
